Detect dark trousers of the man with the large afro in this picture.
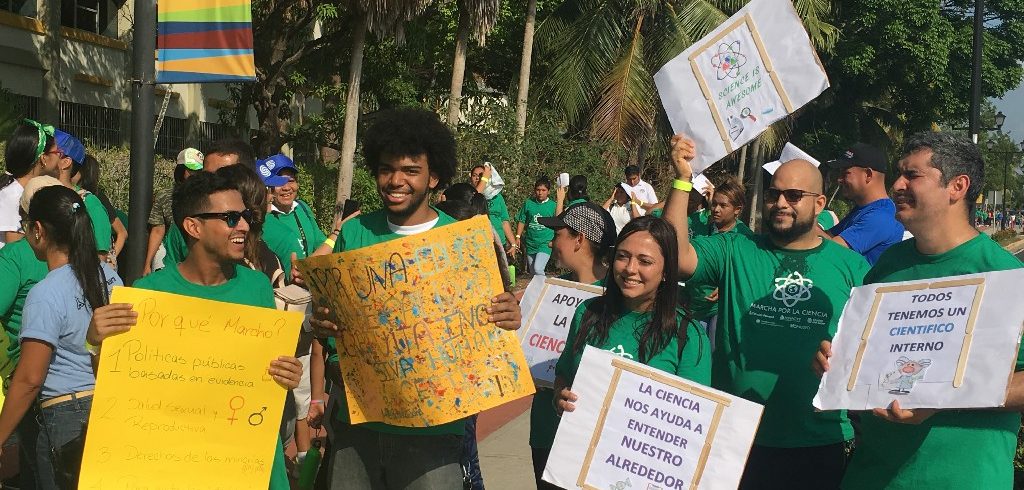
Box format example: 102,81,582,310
327,421,463,490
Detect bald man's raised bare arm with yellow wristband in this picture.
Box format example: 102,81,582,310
662,134,697,278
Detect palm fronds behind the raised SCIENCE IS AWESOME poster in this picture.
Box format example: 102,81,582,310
539,0,838,164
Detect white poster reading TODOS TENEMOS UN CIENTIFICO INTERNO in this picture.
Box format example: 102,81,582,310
813,269,1024,410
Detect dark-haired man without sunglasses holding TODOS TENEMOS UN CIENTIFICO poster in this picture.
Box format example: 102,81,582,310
815,131,1024,488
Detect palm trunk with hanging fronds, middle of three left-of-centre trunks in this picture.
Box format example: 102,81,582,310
447,0,501,128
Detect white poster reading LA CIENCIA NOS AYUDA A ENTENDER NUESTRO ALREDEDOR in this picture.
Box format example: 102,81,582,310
544,346,763,490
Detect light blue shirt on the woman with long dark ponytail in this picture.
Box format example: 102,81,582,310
19,263,122,399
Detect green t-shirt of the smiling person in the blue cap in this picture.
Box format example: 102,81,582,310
263,201,327,279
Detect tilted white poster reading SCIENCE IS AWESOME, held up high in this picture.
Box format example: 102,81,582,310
654,0,828,173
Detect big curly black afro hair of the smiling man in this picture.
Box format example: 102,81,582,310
362,107,458,189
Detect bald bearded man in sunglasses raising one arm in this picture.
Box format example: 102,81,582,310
664,135,868,489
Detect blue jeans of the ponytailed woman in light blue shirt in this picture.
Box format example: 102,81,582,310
36,395,92,489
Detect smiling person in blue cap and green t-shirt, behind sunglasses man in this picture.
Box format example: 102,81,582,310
256,153,341,280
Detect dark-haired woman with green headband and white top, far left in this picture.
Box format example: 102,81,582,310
0,119,60,248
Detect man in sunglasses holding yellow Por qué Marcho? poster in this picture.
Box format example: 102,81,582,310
87,172,302,490
